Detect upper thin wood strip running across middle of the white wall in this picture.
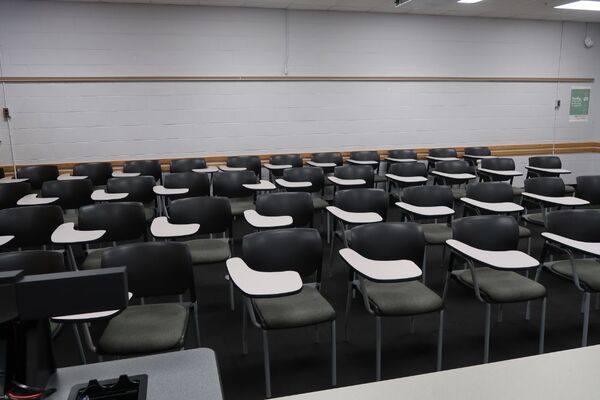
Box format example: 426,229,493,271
0,75,594,83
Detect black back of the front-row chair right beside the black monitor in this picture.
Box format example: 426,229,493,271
102,242,195,301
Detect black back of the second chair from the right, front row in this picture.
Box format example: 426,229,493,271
452,215,519,251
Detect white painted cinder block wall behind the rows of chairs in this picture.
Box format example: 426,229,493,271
0,0,600,181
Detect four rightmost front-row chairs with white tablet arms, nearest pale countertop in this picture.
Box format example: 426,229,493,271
227,206,600,396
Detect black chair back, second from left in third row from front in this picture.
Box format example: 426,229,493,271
42,179,94,210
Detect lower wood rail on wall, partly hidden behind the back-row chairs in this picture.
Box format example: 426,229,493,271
2,142,600,175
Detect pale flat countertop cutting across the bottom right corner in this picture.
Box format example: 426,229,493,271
281,346,600,400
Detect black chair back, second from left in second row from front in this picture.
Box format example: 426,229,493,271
77,202,146,242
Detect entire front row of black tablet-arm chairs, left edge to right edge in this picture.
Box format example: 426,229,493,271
0,210,600,396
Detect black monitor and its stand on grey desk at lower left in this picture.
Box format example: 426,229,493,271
0,267,128,399
